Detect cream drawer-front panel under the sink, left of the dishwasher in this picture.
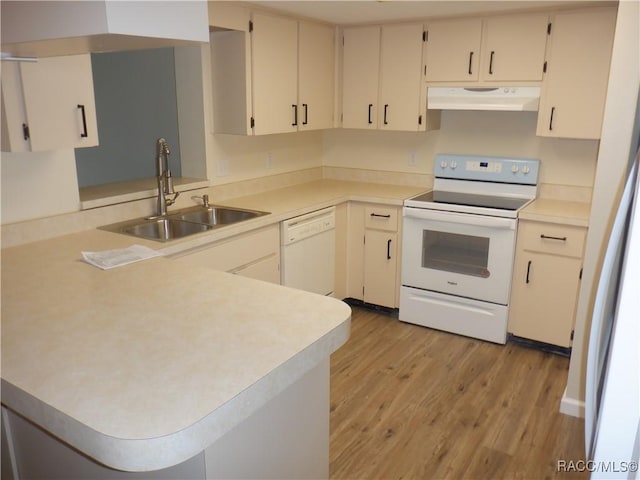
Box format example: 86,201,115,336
172,225,280,272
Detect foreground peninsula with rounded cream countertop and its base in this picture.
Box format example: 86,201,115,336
2,223,351,478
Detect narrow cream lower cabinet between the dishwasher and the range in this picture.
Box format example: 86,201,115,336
347,202,400,308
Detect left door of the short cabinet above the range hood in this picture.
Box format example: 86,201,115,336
425,18,482,82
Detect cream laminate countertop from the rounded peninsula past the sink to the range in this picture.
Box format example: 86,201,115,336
2,180,420,471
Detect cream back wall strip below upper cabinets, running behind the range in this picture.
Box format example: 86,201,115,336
323,111,598,187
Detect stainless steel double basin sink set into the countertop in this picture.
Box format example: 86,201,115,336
100,205,268,242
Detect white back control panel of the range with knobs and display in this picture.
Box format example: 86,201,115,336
433,153,540,185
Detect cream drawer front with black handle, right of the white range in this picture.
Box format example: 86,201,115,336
517,221,587,258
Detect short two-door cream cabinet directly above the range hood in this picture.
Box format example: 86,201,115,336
424,14,548,83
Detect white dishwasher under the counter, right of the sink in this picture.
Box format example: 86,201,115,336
280,207,336,295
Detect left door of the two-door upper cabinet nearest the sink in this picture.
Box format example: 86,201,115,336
251,13,299,135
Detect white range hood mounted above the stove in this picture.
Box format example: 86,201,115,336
427,87,540,112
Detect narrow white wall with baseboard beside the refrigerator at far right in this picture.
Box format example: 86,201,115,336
562,1,640,416
